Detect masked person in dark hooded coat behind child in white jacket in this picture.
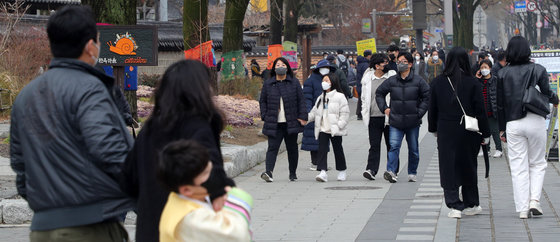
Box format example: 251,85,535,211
301,60,335,171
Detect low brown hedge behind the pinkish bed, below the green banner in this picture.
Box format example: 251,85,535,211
218,77,263,100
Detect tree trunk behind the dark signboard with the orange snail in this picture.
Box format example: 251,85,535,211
82,0,138,120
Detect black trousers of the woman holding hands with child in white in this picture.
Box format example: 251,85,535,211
266,123,299,174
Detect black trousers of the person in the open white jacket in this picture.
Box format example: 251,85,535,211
366,117,392,176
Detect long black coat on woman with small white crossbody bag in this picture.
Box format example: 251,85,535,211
428,75,490,189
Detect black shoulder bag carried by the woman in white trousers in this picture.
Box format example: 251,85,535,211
523,65,550,117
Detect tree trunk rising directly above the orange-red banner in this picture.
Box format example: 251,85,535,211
183,0,210,50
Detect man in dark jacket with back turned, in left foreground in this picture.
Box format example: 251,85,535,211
10,6,134,242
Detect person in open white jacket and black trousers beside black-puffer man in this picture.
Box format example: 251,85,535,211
361,53,398,180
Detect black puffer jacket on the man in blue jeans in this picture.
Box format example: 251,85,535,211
375,71,430,129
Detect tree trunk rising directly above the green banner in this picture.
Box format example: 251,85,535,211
222,0,249,53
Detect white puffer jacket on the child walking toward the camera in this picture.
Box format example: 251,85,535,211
307,91,350,139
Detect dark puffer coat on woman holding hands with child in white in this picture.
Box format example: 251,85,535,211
259,75,307,136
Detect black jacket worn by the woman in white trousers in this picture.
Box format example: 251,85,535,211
498,63,558,131
